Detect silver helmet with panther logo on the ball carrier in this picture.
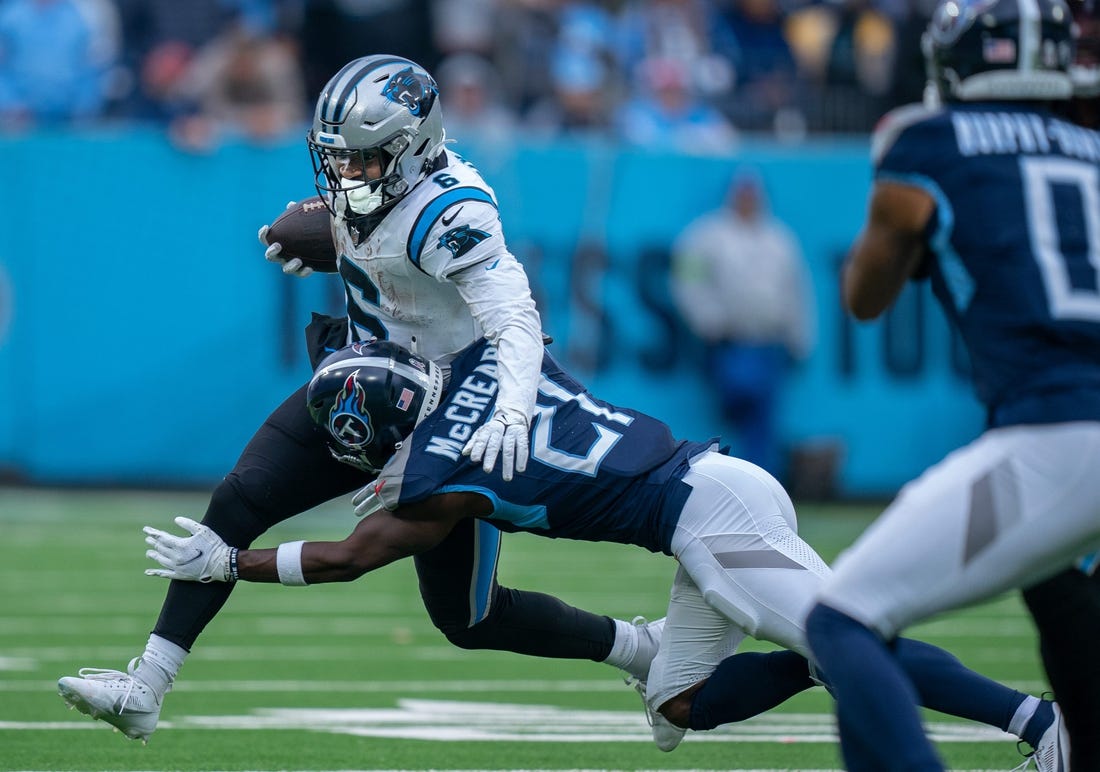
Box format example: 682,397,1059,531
307,55,446,224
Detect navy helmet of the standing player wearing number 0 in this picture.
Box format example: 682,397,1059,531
922,0,1074,101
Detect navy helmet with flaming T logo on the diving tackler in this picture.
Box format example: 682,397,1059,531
306,341,443,472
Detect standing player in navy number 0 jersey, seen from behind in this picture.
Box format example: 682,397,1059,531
807,0,1100,770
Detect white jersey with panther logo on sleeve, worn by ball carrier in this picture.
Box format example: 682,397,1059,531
332,152,542,416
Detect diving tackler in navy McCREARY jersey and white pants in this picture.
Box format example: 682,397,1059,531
145,342,1060,751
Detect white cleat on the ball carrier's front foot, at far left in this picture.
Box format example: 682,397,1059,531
57,658,161,743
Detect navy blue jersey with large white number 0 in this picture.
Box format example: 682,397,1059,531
873,103,1100,427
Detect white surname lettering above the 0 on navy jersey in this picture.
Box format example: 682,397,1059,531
952,111,1100,163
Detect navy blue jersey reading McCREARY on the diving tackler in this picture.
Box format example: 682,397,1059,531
375,342,715,554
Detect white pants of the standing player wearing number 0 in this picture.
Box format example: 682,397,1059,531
820,421,1100,639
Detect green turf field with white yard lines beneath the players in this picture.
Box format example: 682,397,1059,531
0,488,1045,772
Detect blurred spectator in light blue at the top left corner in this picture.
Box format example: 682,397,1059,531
0,0,119,129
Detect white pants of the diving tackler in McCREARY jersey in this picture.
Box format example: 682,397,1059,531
646,452,829,709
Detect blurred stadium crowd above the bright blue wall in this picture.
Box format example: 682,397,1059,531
0,0,934,153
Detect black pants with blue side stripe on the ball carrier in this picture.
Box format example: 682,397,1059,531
153,386,615,662
